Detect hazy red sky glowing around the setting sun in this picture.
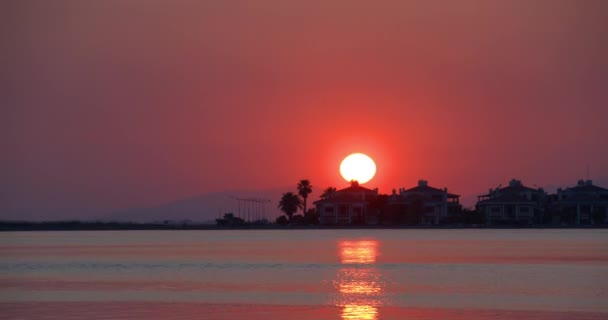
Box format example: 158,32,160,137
0,0,608,218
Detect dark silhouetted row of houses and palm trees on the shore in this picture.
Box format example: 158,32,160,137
256,179,608,227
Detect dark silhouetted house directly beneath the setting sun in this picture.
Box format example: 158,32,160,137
313,181,378,225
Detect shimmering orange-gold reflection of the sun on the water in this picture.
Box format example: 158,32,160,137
334,240,385,320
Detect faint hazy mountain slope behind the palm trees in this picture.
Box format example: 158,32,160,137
102,187,321,223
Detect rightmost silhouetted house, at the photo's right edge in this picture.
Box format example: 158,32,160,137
551,180,608,225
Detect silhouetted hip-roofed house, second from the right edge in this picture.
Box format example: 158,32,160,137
477,179,547,224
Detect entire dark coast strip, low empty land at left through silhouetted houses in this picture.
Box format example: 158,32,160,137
0,179,608,231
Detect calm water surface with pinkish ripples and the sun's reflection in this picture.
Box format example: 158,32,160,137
0,230,608,320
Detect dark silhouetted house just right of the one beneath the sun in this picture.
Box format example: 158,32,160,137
387,180,462,224
